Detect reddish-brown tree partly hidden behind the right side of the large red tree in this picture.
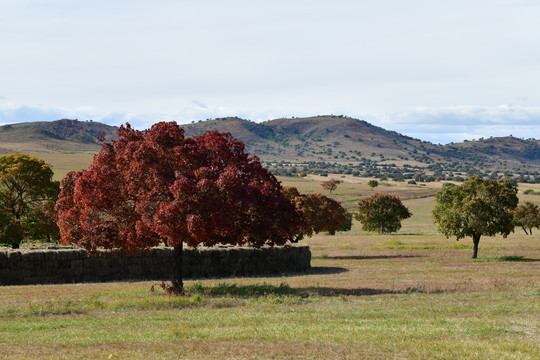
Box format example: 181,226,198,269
282,187,351,242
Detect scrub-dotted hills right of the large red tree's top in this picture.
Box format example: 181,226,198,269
182,116,540,169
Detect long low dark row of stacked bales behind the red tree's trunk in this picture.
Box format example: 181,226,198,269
0,244,311,285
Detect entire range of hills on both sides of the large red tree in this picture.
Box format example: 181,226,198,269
0,116,540,176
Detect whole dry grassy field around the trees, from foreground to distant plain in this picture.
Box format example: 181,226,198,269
0,178,540,359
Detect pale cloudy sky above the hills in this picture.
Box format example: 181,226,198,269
0,0,540,144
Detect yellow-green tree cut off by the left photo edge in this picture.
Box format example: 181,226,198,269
0,154,59,249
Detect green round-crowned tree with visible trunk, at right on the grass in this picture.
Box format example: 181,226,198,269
433,176,518,259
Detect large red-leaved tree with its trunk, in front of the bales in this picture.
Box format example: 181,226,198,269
56,122,300,293
